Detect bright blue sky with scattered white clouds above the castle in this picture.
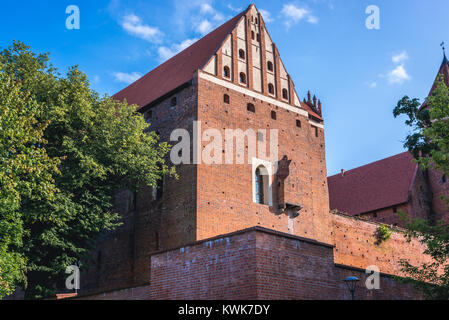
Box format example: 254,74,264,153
0,0,449,175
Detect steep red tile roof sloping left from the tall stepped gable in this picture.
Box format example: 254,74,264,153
114,9,248,107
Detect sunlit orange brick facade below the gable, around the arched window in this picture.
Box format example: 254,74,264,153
197,78,331,243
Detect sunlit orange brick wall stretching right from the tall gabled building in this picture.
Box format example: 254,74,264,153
332,214,430,275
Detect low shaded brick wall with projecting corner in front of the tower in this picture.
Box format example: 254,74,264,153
78,228,420,300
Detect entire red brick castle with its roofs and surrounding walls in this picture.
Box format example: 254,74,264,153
76,5,447,299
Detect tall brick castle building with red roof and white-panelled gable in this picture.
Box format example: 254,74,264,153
83,5,331,291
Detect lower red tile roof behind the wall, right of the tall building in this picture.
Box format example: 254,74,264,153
328,152,418,215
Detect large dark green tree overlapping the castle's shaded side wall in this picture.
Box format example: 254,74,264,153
0,42,175,298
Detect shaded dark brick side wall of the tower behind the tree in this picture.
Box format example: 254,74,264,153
81,85,197,293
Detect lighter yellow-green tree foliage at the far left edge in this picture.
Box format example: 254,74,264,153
0,64,59,299
